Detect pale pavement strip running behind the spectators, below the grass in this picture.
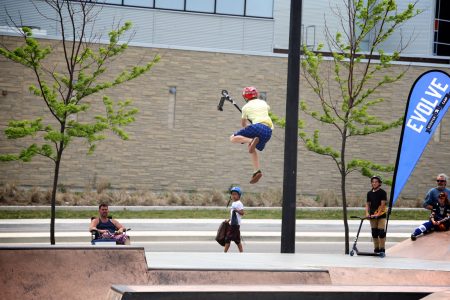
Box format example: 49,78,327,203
0,219,420,244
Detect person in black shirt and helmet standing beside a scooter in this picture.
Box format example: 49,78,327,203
366,176,387,253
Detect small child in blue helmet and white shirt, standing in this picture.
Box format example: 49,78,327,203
223,186,244,252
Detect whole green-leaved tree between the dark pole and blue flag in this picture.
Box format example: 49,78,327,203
273,0,420,254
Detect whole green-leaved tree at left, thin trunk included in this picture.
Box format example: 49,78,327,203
0,0,159,245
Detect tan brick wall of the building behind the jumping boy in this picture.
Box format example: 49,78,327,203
0,36,450,203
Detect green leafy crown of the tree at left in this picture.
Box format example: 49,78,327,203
0,22,160,161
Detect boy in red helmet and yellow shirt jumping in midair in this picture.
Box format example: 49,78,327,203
230,86,273,183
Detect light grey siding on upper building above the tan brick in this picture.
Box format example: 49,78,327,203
0,0,442,56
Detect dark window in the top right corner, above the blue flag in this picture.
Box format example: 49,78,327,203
433,0,450,56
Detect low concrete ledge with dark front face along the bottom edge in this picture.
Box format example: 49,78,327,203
108,283,446,300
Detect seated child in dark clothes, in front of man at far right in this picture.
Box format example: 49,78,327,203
411,192,450,241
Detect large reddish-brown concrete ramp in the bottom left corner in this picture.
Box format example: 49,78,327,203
0,246,148,299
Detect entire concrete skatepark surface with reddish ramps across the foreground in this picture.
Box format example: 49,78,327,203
0,232,450,300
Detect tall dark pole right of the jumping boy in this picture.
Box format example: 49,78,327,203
281,0,302,253
